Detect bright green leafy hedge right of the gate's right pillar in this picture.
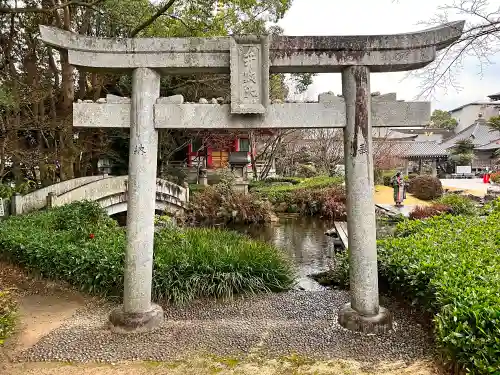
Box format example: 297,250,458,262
379,216,500,374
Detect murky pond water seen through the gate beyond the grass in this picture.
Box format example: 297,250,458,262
231,215,398,291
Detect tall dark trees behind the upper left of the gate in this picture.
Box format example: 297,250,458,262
0,0,306,184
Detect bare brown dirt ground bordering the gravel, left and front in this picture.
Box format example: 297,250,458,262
0,263,442,375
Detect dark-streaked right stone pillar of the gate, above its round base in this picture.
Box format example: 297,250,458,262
342,66,379,316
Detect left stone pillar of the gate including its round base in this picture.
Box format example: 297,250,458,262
110,68,163,332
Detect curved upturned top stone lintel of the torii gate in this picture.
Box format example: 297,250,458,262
40,21,464,74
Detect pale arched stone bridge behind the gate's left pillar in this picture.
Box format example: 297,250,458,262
12,175,189,215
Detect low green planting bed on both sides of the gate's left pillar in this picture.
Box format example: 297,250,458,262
0,202,294,303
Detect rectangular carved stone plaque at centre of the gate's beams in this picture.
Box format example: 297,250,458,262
230,36,269,114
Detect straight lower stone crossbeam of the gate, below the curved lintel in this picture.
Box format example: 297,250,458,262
73,97,431,129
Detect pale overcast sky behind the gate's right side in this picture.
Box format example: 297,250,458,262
279,0,500,110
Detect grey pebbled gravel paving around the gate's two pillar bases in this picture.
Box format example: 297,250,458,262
15,290,433,366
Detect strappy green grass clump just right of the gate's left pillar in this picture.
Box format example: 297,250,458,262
153,228,294,303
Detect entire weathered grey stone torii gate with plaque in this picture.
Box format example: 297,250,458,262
40,21,464,333
